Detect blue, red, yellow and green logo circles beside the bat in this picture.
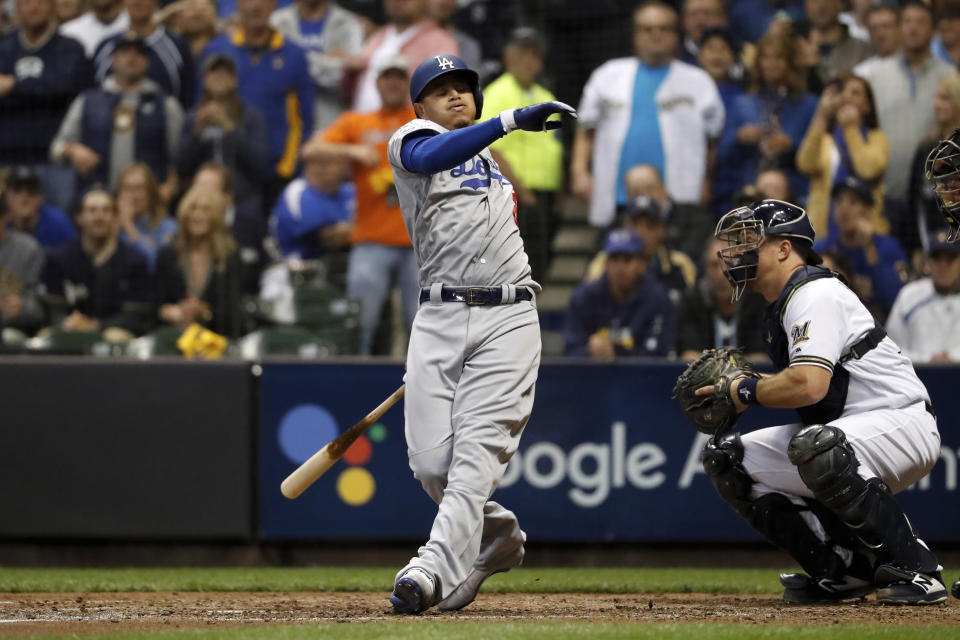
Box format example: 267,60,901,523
277,404,387,507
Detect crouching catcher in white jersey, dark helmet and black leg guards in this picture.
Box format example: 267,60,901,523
697,200,947,604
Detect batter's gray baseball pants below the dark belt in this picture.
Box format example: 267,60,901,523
404,296,540,600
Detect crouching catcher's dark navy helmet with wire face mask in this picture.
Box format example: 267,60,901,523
714,199,822,300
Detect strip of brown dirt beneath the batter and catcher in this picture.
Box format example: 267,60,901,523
0,593,960,638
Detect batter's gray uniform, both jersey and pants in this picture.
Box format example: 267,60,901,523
388,120,540,609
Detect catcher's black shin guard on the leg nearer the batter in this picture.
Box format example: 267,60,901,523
700,433,848,579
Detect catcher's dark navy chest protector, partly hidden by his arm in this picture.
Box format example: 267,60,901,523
763,266,850,425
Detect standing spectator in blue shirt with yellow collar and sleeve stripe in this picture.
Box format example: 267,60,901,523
198,0,314,211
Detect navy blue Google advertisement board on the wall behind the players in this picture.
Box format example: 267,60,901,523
260,363,960,542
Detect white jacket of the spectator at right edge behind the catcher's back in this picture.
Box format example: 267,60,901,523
887,278,960,362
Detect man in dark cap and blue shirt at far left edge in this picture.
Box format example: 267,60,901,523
4,166,77,249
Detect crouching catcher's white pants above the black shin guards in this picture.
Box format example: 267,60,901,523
741,402,940,539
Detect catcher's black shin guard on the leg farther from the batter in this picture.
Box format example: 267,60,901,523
787,425,940,575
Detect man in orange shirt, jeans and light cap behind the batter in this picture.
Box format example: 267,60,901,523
303,56,420,355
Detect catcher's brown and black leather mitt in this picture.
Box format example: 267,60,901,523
673,347,760,437
